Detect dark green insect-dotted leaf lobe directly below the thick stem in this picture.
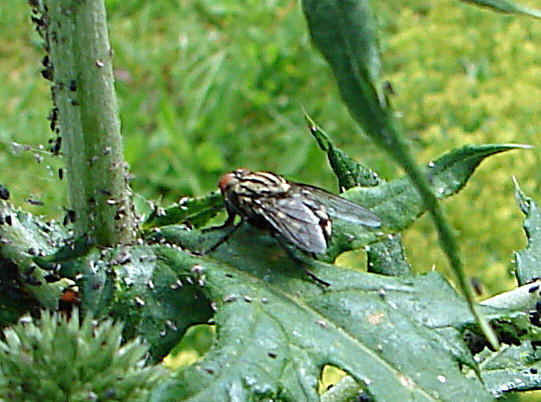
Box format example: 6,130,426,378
70,245,212,360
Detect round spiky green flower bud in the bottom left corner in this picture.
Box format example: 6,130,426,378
0,311,163,402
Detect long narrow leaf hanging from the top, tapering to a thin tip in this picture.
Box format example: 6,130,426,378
303,0,498,347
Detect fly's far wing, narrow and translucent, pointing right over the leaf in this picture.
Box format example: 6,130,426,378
298,184,381,228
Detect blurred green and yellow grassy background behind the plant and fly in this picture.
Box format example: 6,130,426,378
0,0,541,295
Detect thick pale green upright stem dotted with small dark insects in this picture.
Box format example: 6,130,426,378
46,0,135,245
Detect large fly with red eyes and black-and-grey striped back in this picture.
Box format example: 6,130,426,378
207,169,381,285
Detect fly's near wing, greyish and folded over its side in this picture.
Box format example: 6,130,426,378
257,197,331,253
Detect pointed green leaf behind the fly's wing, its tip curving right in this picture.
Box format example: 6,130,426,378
327,144,523,258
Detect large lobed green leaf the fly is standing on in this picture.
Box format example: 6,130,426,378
39,218,538,400
